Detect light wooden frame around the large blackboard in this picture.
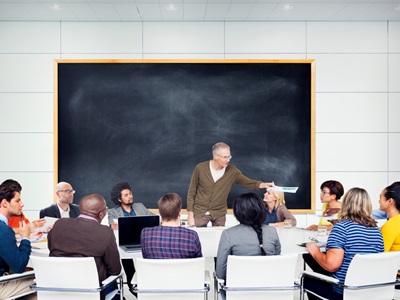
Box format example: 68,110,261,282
54,59,316,213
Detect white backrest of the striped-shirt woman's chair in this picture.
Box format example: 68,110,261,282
343,252,400,300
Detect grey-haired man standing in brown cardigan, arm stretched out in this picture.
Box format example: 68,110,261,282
187,142,274,227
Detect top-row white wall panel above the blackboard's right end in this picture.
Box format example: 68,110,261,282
225,22,306,53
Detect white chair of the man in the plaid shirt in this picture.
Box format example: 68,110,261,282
132,257,210,300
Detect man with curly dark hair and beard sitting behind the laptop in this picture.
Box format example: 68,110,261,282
108,182,154,297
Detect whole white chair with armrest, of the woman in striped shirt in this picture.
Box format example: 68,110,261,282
301,252,400,300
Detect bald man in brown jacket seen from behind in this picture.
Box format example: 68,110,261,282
48,194,121,297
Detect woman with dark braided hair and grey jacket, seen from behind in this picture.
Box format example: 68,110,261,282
216,193,281,280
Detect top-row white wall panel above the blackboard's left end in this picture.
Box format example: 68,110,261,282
61,22,142,54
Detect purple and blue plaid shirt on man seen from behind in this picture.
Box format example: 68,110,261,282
141,226,203,259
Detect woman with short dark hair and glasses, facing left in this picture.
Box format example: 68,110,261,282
307,180,344,231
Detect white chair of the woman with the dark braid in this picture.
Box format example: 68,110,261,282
214,254,300,300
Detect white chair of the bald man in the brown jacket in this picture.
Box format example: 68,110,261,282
31,256,123,300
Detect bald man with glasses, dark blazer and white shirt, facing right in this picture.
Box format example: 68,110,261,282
39,182,79,219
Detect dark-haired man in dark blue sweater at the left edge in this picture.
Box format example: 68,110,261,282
0,179,36,299
